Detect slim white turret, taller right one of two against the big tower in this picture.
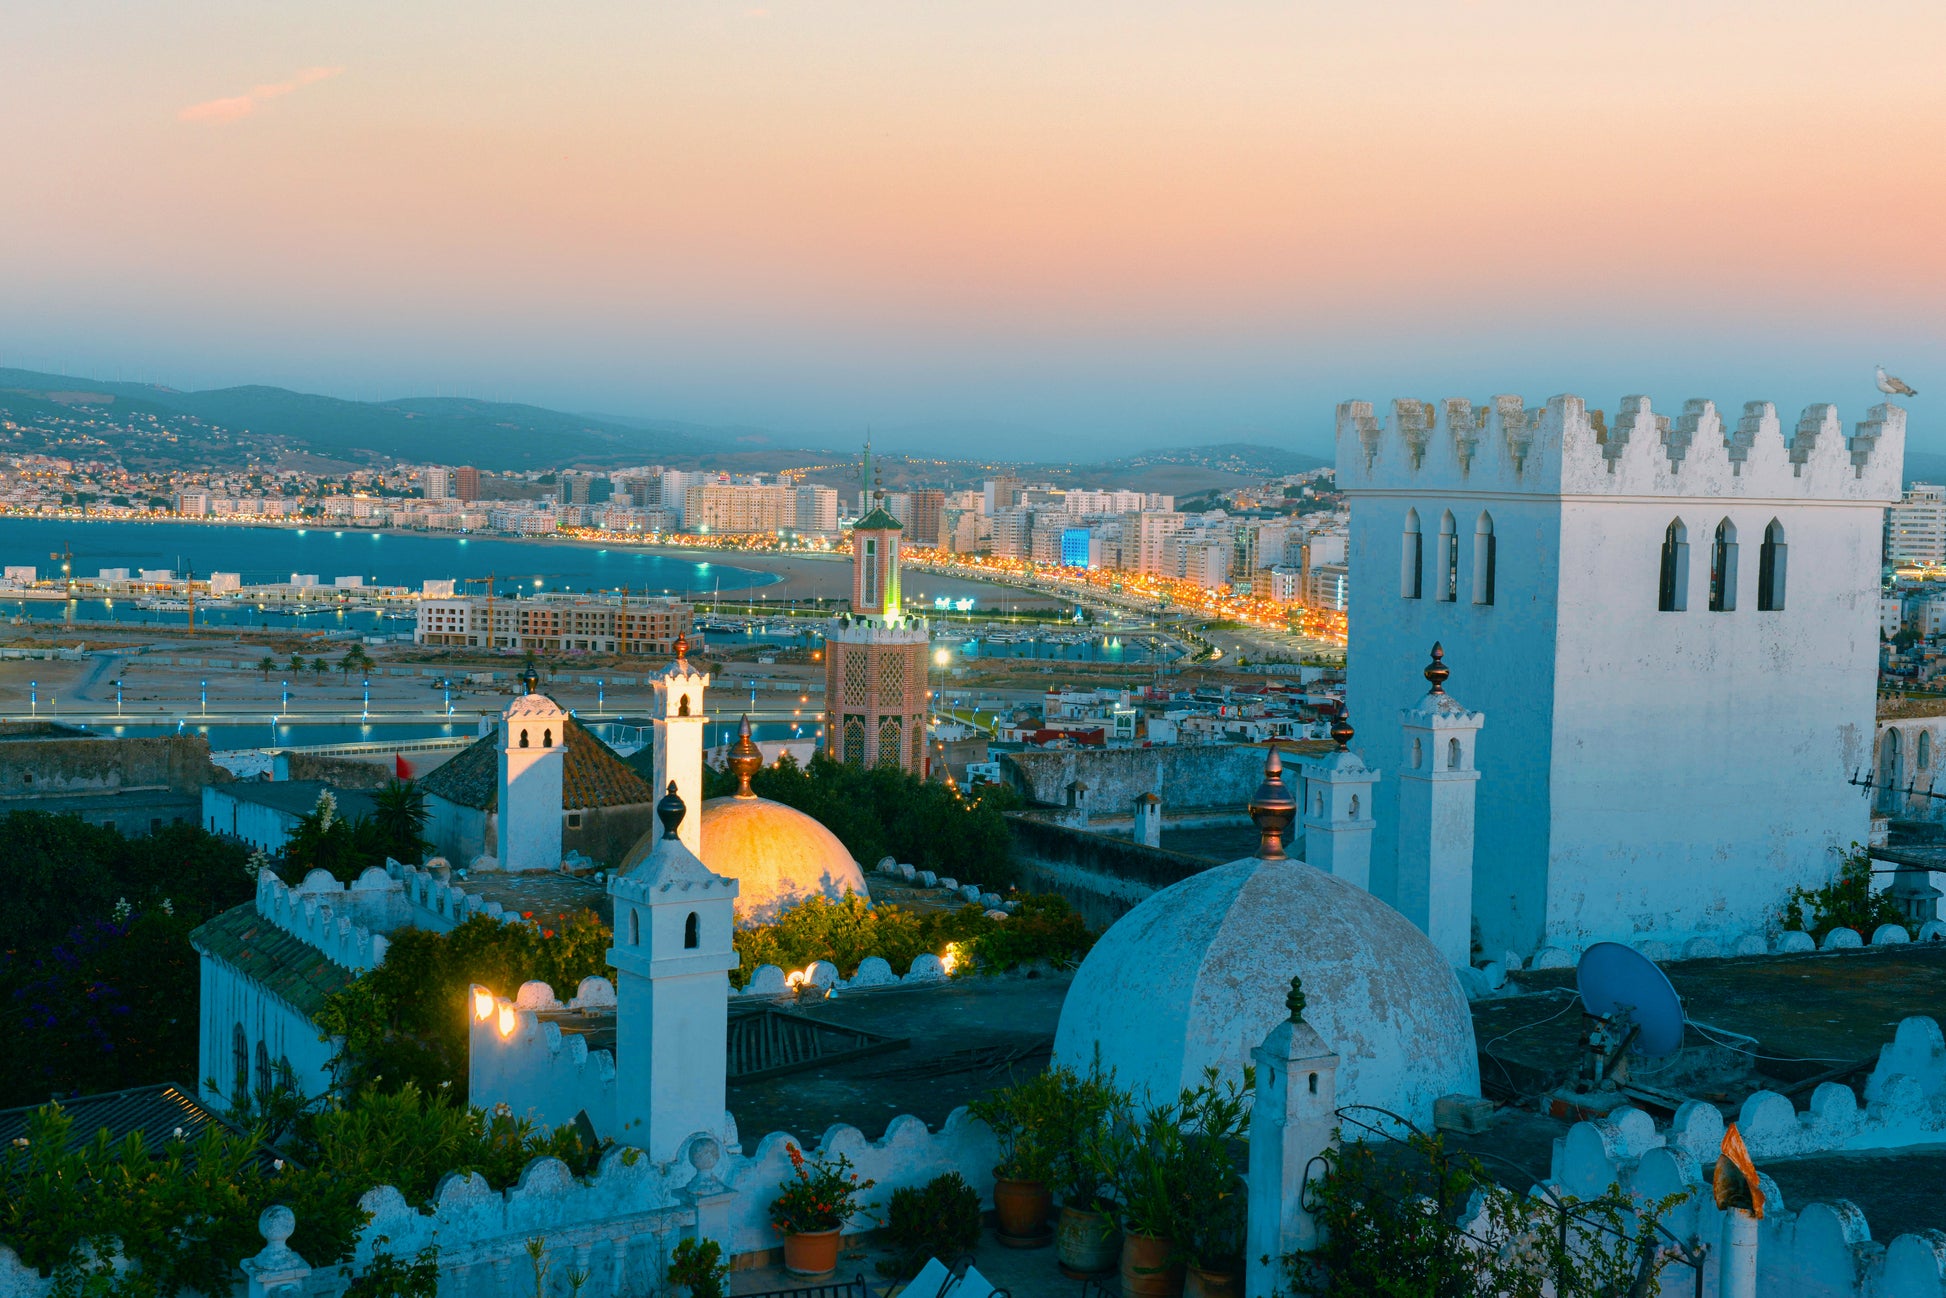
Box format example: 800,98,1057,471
1399,644,1487,969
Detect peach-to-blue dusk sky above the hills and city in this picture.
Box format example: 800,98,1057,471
0,0,1946,459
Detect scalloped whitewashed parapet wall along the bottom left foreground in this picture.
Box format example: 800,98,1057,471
0,1109,998,1298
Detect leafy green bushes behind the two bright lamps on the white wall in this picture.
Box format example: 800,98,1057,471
317,911,611,1094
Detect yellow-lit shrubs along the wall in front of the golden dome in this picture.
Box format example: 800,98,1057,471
732,893,1094,987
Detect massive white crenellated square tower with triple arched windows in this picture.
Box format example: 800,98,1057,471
1337,397,1905,954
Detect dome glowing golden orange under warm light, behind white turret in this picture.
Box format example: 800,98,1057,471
703,798,872,924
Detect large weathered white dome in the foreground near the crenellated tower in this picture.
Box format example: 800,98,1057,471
1055,858,1479,1125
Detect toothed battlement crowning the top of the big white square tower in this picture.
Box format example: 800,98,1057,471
1337,395,1905,504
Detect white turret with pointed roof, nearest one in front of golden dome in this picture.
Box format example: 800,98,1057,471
607,784,738,1162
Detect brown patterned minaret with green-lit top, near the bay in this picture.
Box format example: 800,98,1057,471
825,508,932,775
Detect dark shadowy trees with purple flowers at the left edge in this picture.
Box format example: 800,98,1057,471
0,811,255,1105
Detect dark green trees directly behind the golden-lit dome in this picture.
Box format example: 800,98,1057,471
684,749,1016,891
